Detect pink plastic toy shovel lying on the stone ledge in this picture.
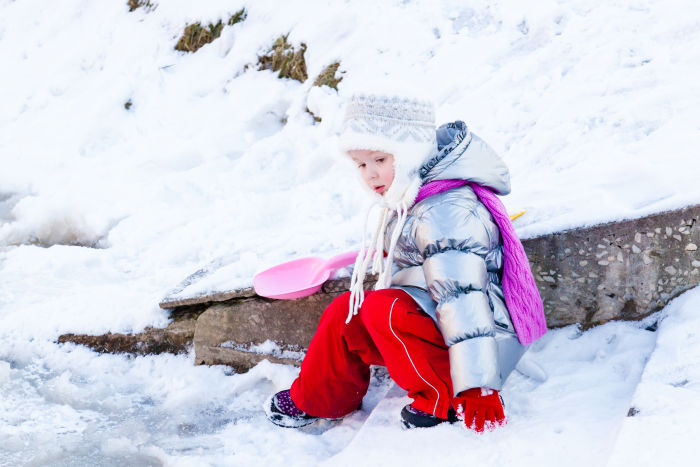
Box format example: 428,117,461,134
253,251,359,300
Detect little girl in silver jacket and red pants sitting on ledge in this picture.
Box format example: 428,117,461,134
265,88,546,431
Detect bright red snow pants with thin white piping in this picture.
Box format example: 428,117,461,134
291,289,452,418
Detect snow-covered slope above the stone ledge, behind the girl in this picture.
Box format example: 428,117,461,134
0,0,700,340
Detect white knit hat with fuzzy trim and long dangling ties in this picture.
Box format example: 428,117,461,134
339,91,437,323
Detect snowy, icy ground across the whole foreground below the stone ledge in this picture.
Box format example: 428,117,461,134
0,288,700,466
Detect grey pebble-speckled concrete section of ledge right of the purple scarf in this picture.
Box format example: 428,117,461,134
523,205,700,328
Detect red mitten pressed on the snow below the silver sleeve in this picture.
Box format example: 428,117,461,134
452,388,506,432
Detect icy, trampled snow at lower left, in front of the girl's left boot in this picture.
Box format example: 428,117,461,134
0,344,388,466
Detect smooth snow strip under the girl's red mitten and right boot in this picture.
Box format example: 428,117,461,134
327,323,658,466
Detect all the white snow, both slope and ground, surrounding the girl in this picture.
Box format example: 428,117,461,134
0,0,700,465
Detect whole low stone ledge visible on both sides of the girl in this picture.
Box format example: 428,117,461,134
59,205,700,371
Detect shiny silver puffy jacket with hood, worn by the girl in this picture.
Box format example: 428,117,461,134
385,121,525,394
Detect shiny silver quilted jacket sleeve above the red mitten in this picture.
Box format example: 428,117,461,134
415,200,503,394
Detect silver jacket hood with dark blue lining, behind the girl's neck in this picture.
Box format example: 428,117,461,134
420,120,510,195
